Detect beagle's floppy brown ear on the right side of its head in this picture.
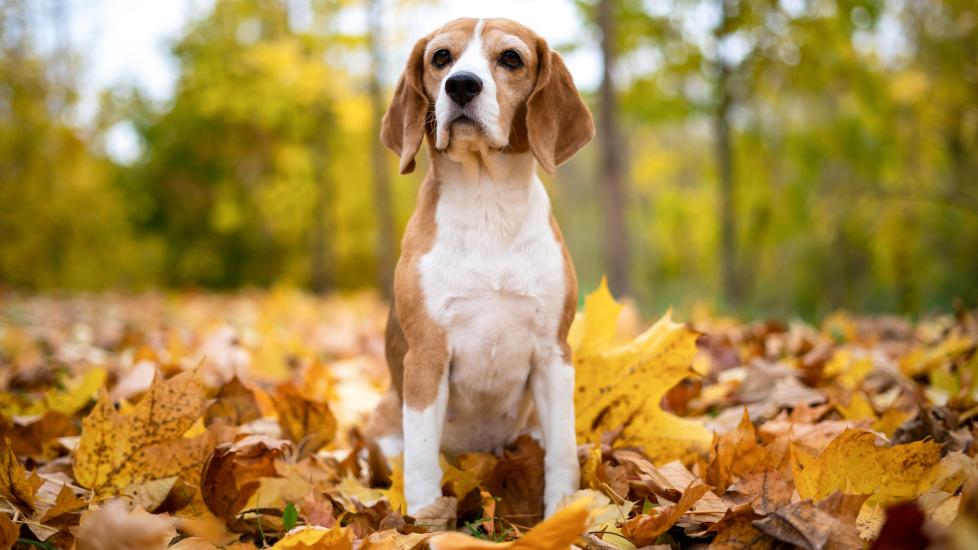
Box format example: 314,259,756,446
526,44,594,174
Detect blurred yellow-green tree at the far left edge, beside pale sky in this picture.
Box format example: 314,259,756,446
0,0,154,290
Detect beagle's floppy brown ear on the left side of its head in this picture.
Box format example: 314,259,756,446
380,37,429,174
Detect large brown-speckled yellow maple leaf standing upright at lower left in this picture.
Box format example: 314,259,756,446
74,371,213,495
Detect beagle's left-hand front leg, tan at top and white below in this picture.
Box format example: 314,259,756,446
403,350,449,516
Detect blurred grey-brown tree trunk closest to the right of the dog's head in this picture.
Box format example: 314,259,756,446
598,0,629,295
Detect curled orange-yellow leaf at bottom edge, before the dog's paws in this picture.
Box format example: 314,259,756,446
429,500,588,550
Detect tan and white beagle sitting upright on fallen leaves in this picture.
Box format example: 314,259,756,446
367,15,594,517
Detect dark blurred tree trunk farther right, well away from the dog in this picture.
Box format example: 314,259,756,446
713,0,741,305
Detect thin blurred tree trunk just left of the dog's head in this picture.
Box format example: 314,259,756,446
367,0,396,298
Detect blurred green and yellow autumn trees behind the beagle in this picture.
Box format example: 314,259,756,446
0,0,978,316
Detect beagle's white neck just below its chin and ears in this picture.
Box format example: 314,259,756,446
431,149,549,244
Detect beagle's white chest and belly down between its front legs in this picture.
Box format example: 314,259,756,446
420,169,566,449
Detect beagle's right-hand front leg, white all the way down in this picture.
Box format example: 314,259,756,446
531,349,581,516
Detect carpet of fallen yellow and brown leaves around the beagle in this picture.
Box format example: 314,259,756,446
0,286,978,550
